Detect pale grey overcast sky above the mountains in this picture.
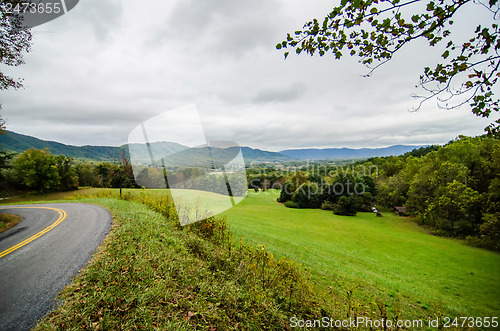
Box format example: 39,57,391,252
0,0,491,151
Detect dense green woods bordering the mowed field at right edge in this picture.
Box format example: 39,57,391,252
364,136,500,250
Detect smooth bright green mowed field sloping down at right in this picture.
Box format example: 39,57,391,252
224,191,500,317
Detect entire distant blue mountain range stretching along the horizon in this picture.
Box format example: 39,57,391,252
0,131,430,164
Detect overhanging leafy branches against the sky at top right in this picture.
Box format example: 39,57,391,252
276,0,500,135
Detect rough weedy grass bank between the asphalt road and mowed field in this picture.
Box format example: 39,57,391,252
32,193,339,330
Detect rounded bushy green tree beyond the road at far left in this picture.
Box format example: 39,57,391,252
14,148,61,192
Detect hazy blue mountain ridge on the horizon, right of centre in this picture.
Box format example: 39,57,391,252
280,145,425,160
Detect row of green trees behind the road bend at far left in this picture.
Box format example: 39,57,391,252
0,148,137,192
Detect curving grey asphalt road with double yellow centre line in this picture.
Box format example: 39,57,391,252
0,203,111,330
